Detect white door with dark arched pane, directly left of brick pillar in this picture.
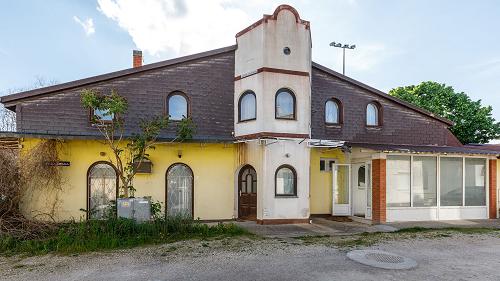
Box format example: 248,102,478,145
352,163,367,215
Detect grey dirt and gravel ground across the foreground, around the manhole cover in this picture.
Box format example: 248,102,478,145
0,232,500,281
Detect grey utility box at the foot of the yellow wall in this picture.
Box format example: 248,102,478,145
117,197,151,222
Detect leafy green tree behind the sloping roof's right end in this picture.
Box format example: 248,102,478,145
389,81,500,144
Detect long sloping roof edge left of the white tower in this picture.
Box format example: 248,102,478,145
0,45,236,104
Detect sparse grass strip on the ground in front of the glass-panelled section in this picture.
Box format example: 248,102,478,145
297,227,500,249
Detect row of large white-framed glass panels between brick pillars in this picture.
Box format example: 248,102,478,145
386,155,487,207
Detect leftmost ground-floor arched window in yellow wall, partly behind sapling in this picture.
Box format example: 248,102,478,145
87,162,118,219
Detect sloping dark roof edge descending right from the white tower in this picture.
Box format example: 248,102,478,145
312,62,454,126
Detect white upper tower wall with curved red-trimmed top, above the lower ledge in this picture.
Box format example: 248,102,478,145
234,6,311,137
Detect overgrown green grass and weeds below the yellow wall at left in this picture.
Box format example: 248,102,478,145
0,218,248,256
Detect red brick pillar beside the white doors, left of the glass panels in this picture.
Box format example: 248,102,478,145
372,159,386,224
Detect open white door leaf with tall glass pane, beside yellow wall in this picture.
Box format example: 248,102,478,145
332,164,351,216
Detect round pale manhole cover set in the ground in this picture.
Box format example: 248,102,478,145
347,250,417,269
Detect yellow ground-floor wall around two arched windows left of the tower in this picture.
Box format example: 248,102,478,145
22,139,237,221
